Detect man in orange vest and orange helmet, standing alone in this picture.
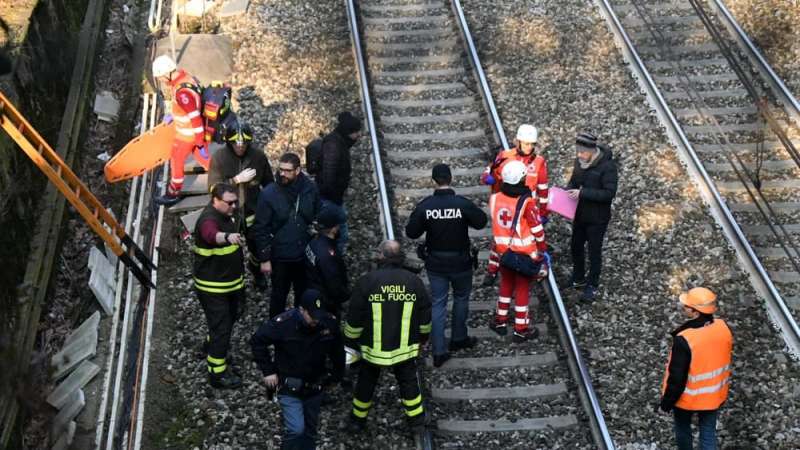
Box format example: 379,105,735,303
660,287,733,450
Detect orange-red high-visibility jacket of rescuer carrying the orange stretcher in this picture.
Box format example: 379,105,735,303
170,70,205,145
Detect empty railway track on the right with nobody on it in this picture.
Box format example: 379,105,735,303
598,0,800,355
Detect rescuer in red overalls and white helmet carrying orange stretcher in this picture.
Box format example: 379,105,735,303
153,55,206,205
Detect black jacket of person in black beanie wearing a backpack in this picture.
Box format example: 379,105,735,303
315,131,356,205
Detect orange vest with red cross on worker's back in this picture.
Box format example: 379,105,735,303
489,192,544,259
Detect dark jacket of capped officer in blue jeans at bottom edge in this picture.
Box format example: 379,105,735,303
250,308,340,384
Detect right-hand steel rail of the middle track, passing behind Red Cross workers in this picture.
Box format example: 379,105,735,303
450,0,615,450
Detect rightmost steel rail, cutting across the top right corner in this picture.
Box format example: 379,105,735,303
710,0,800,126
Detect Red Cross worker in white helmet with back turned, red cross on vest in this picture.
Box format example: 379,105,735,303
489,161,547,343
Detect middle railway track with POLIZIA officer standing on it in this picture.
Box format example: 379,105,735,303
346,0,613,448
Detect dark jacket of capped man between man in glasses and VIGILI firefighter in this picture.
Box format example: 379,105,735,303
306,235,350,306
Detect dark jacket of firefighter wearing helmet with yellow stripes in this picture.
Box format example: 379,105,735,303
208,145,275,221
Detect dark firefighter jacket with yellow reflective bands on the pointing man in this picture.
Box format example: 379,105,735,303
193,205,244,294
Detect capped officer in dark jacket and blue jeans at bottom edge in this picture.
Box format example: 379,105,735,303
250,289,340,450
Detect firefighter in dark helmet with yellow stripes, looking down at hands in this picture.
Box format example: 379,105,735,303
208,121,275,292
